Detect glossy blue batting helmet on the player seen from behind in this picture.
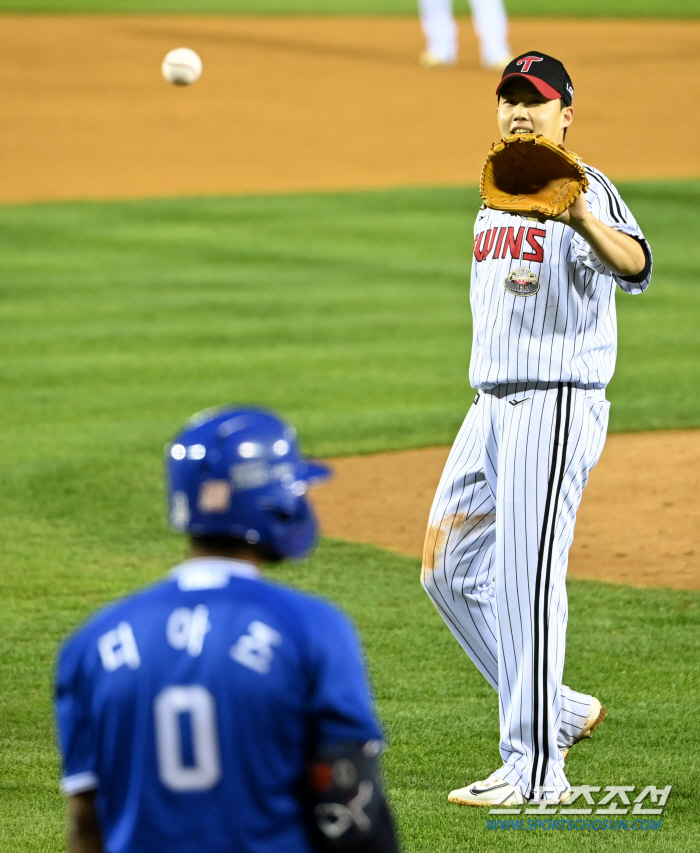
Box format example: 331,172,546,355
166,408,330,557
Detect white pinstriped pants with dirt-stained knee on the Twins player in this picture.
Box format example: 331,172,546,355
421,382,609,799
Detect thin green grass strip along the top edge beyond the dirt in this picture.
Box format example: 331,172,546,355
0,0,700,18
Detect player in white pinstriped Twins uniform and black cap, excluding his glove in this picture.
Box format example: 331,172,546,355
422,50,652,806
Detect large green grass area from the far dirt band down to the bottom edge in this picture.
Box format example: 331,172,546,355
0,181,700,853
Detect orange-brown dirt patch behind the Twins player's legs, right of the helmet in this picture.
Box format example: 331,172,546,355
314,430,700,590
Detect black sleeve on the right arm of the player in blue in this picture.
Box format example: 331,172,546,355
309,741,399,853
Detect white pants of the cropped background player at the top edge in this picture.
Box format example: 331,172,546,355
418,0,511,71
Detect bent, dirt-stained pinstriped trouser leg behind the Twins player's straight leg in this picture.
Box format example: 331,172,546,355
421,395,592,748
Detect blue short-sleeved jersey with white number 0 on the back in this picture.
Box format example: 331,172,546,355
56,558,381,853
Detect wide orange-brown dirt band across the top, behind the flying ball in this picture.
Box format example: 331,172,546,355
0,15,700,202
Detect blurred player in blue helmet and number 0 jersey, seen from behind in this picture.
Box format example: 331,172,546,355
56,409,397,853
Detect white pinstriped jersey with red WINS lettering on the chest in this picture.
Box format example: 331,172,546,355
469,166,651,388
